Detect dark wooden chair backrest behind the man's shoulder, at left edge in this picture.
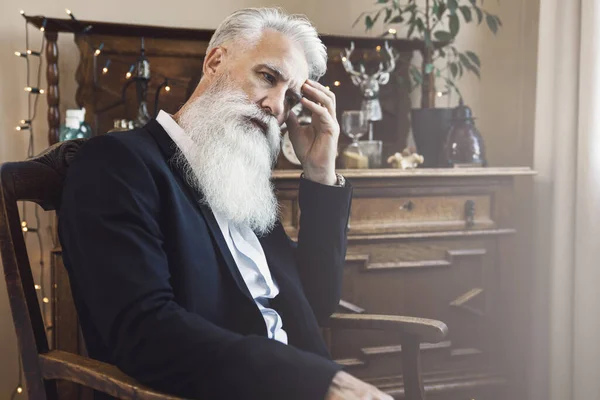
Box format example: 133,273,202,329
0,139,85,399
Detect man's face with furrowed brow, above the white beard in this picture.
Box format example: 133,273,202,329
219,30,308,126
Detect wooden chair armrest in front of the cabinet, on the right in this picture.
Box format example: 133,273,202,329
326,313,448,343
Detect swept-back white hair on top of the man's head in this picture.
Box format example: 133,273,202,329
206,8,327,80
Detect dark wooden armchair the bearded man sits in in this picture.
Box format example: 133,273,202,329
0,139,447,400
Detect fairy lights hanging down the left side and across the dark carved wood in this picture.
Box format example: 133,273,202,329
10,9,192,400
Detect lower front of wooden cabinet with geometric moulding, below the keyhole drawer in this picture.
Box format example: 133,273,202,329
332,237,496,376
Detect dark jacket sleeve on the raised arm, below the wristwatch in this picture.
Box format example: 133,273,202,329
296,178,352,323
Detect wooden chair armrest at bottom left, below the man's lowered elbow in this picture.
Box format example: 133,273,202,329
39,350,183,400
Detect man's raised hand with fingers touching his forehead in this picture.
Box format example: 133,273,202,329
286,79,340,185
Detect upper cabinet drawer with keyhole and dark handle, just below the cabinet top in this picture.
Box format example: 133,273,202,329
349,193,495,235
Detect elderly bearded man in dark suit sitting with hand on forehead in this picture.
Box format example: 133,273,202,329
59,9,388,400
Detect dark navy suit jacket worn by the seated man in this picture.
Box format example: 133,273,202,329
59,120,351,400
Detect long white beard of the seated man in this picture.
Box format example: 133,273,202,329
175,75,281,235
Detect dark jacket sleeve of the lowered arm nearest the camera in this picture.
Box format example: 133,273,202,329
59,136,340,400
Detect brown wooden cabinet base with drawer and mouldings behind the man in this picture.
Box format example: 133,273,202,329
53,168,531,400
